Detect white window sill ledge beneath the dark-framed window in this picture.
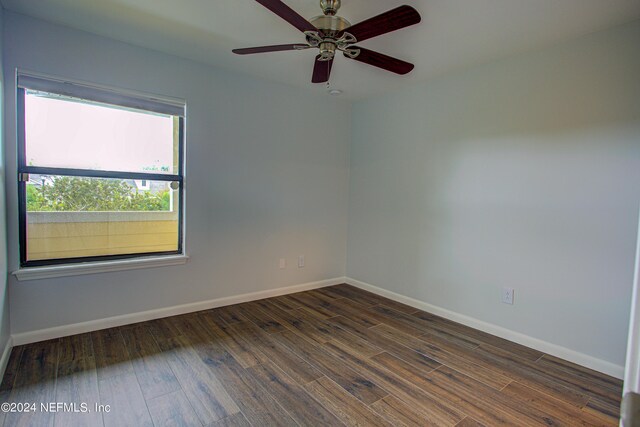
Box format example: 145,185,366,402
12,255,189,281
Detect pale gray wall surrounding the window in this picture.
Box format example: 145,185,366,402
4,12,351,333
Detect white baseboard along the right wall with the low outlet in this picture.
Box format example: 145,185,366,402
345,277,624,379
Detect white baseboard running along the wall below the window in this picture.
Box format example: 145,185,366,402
10,277,346,348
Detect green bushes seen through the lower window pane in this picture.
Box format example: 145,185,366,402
27,176,170,212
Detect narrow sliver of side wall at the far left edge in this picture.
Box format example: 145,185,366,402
0,5,11,354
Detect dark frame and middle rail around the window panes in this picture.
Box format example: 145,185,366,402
17,87,185,268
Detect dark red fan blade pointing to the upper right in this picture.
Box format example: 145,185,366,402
338,6,422,42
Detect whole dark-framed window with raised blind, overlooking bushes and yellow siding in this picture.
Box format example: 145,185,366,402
17,74,184,267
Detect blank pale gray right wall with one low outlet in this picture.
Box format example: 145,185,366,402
347,22,640,366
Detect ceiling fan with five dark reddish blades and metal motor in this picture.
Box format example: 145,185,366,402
233,0,421,83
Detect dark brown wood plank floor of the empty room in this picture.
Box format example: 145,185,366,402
0,285,622,427
